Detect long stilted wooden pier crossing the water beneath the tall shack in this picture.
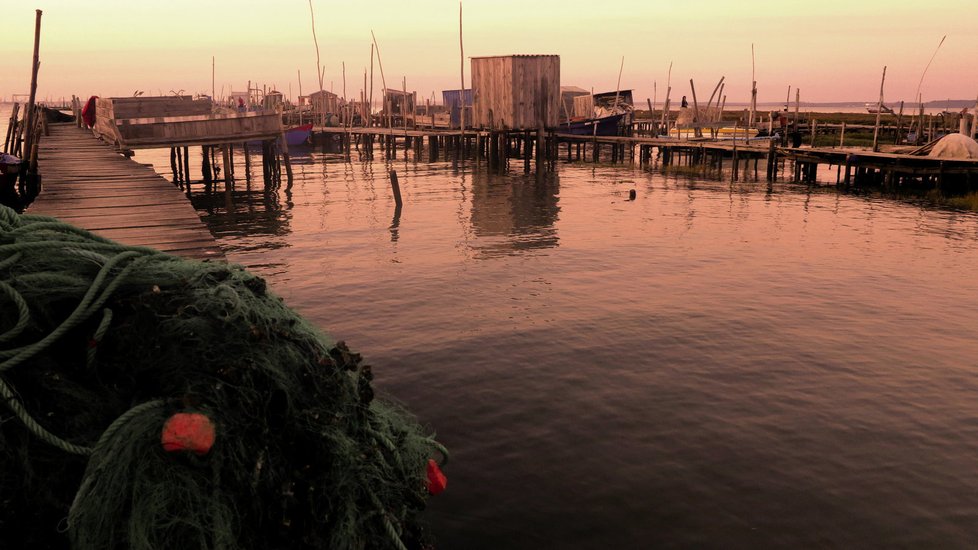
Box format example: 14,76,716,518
314,127,978,188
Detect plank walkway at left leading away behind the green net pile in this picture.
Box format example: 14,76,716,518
27,123,226,261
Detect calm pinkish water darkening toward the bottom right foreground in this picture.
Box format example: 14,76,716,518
7,102,978,549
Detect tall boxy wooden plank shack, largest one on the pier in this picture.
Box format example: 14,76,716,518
472,55,560,129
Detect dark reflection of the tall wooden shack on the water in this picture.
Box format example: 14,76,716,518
470,172,560,258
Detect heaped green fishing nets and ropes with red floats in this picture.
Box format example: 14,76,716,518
0,206,448,550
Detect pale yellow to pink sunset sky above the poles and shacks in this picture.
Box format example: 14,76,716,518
0,0,978,104
